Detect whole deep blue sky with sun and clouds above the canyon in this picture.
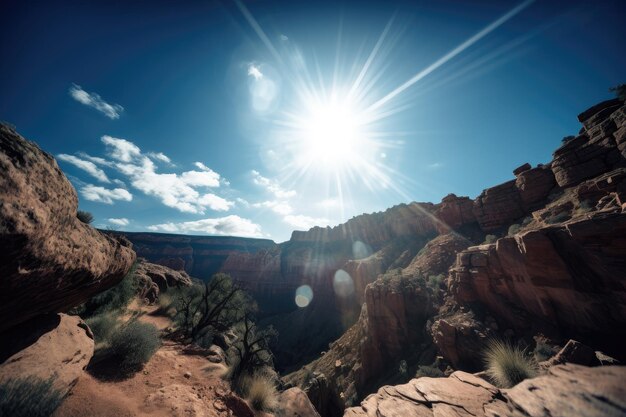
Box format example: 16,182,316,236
0,0,626,242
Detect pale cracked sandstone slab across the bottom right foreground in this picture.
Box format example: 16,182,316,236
344,365,626,417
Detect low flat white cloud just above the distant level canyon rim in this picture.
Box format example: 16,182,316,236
148,215,263,237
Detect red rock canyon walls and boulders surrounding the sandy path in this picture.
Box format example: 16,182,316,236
0,95,626,417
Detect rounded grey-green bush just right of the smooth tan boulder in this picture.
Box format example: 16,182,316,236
110,320,161,372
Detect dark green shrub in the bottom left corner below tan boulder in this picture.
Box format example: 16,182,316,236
0,376,63,417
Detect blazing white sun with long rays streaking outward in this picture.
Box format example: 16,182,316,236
235,0,534,221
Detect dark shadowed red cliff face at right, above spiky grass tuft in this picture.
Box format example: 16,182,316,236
450,212,626,356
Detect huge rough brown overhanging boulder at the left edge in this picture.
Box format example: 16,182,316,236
0,125,135,332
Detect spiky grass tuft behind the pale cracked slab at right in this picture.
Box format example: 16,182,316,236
484,340,537,388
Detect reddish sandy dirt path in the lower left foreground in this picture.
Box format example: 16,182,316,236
54,305,232,417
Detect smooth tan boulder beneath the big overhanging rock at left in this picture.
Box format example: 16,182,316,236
0,314,94,395
